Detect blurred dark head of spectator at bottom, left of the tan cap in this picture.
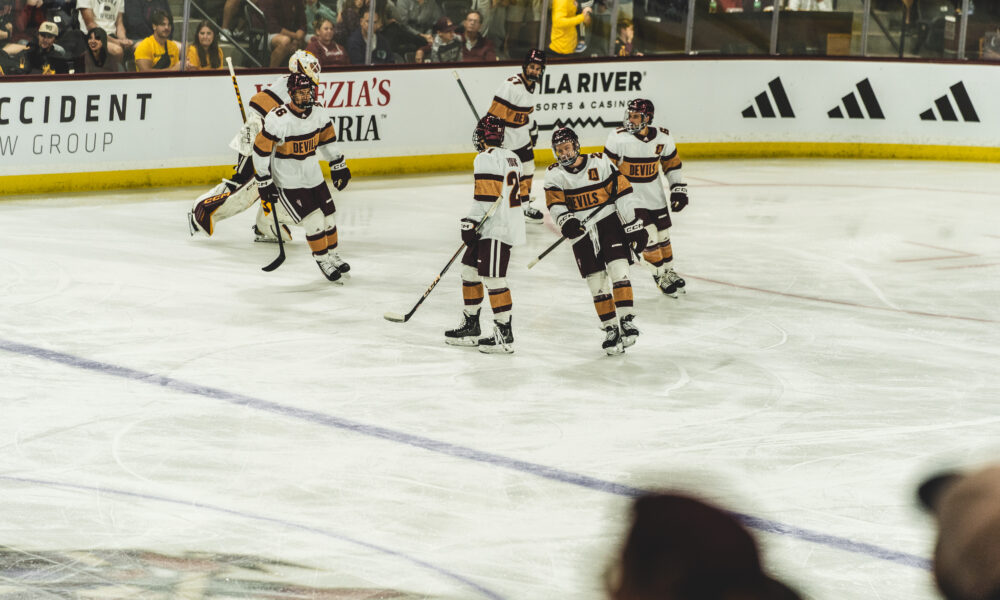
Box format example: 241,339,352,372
608,493,799,600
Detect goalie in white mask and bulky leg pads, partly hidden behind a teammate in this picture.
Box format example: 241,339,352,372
188,50,320,242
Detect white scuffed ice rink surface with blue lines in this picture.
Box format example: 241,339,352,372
0,160,1000,600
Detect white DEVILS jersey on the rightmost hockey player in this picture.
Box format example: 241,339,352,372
604,127,682,221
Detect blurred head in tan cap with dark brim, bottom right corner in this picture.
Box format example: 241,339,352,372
917,464,1000,600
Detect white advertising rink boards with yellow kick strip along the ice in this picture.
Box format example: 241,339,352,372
0,58,1000,194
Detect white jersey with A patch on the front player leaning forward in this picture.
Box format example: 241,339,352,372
545,152,632,226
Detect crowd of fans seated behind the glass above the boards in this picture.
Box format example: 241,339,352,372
0,0,652,75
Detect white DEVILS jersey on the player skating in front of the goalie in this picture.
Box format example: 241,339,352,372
253,104,344,188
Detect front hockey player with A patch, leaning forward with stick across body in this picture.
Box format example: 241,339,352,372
545,127,647,354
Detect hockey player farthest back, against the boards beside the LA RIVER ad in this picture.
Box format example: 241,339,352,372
488,49,545,223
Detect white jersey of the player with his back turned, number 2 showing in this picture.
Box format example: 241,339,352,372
468,148,526,246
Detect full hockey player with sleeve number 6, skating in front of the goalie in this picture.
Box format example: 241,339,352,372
253,73,351,281
